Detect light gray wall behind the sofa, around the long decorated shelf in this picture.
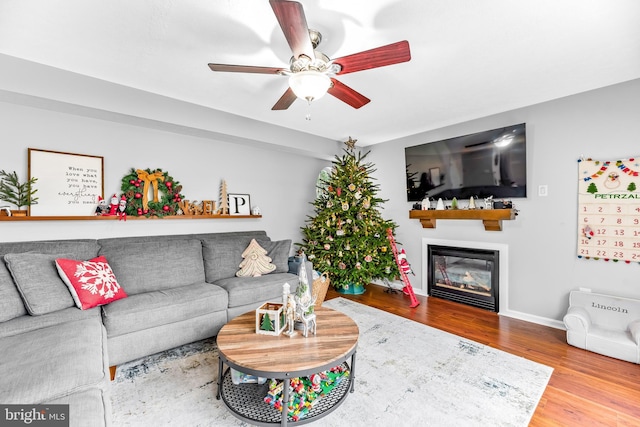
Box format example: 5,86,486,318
0,102,330,241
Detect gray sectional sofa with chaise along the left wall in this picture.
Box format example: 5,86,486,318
0,231,298,426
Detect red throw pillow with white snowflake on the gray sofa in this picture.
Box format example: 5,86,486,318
56,256,127,310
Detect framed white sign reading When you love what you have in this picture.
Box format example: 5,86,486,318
29,148,104,216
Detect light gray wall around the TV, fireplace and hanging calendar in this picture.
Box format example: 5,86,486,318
368,80,640,326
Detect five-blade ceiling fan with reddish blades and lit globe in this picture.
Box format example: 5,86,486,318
209,0,411,110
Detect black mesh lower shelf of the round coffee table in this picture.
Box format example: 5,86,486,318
220,362,352,426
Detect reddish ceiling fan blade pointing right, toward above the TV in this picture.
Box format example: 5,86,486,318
333,40,411,74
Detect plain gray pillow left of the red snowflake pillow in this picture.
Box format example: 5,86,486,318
4,252,74,316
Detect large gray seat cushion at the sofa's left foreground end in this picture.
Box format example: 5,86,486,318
0,318,108,404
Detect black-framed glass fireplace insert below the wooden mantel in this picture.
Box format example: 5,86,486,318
427,245,500,313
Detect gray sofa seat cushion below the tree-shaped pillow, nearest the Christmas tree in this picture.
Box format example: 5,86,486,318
215,273,298,307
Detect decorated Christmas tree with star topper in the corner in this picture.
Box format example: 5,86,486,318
299,138,398,294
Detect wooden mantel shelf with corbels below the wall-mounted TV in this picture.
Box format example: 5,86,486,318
409,209,516,231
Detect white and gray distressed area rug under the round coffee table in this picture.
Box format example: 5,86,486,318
111,298,553,427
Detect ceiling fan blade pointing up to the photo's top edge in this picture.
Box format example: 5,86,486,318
269,0,315,59
